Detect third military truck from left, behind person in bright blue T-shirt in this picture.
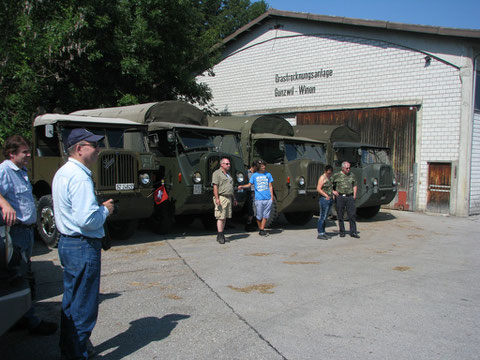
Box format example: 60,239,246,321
208,115,326,225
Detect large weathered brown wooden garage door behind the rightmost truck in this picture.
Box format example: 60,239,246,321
297,106,417,210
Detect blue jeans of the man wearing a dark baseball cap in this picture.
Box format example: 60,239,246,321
58,235,102,359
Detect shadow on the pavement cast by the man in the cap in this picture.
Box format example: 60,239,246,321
95,314,190,360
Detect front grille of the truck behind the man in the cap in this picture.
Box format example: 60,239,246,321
98,153,138,190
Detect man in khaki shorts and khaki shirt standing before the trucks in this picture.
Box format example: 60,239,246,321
212,158,237,244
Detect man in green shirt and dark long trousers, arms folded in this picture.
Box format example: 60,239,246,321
332,161,360,239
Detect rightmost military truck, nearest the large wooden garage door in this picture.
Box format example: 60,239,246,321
295,125,397,218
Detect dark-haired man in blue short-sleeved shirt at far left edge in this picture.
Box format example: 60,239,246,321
0,135,58,335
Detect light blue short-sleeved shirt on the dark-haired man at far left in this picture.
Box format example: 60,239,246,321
0,160,37,225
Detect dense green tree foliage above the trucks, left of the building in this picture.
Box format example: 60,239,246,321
0,0,268,139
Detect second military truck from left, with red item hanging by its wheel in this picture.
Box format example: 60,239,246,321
74,101,247,233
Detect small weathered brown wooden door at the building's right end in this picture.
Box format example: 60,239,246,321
427,163,452,214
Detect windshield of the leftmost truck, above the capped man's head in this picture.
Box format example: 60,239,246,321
62,127,148,152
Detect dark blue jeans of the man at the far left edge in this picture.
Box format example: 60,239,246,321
10,226,41,328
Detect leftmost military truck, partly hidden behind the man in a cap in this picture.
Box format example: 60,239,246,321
31,114,156,247
